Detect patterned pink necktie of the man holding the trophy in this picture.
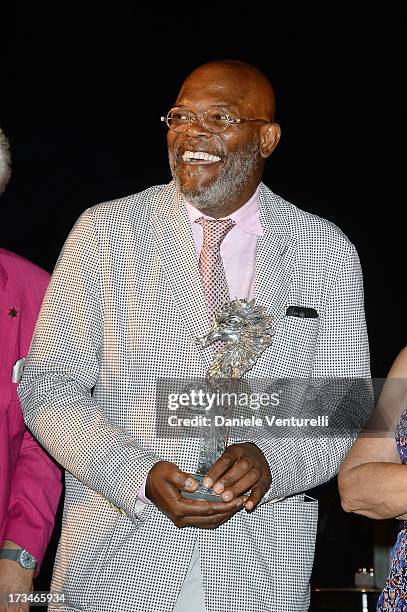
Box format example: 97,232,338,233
195,217,235,320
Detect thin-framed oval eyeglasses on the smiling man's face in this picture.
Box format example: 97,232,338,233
161,106,270,134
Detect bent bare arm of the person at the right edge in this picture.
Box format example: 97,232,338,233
338,348,407,519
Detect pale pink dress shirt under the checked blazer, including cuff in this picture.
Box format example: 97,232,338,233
137,185,263,504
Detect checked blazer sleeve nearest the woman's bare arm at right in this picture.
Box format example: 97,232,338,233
245,245,373,502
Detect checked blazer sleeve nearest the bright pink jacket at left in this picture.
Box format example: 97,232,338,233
19,209,160,519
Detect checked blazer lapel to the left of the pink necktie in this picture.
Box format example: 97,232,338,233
151,183,213,367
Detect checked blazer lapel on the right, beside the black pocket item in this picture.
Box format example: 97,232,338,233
254,184,296,324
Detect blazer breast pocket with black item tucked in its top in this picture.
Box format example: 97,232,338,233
273,316,319,377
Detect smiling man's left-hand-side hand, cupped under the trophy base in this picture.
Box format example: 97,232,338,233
146,461,243,529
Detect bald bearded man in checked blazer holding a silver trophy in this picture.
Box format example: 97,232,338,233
20,61,369,612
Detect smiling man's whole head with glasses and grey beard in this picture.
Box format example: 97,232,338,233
167,60,280,217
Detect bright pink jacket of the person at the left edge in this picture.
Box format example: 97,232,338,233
0,249,62,572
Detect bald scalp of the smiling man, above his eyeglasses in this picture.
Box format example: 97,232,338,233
178,60,276,122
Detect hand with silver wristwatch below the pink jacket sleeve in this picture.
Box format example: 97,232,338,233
0,540,34,612
